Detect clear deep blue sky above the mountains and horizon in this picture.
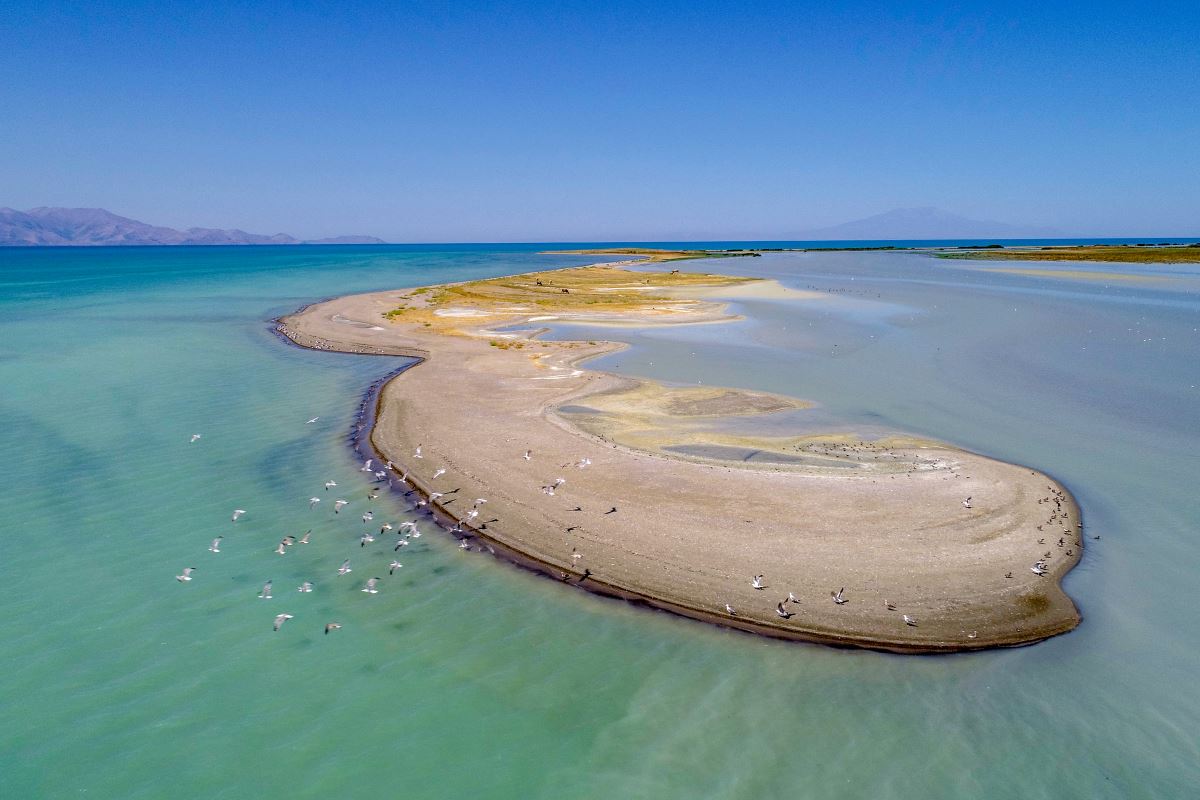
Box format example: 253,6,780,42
0,0,1200,241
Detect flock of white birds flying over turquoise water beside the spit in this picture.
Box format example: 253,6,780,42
175,416,453,634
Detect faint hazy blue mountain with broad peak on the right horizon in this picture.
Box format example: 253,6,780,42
797,206,1063,241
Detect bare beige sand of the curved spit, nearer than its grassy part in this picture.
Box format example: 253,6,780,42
280,278,1082,652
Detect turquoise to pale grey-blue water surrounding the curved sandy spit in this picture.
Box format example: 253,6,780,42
0,246,1200,799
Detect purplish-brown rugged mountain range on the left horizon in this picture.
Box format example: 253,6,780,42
0,207,385,247
